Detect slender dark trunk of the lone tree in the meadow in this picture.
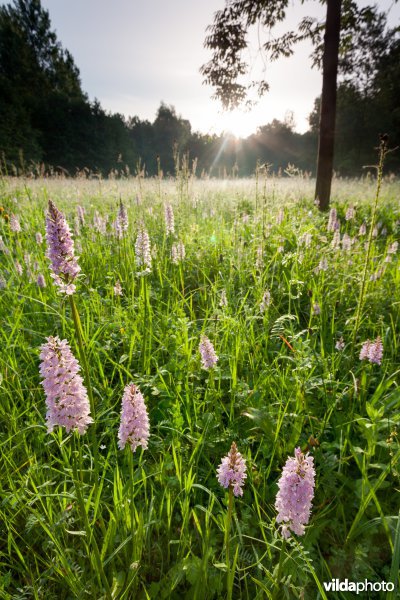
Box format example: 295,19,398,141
315,0,342,210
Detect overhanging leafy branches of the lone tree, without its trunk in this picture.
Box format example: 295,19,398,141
200,0,399,109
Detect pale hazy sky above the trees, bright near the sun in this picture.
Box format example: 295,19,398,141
0,0,400,137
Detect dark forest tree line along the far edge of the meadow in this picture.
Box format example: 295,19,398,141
0,0,400,177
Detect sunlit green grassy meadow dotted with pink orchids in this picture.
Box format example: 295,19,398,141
0,173,400,600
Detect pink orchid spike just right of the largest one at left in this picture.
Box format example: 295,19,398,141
118,383,150,452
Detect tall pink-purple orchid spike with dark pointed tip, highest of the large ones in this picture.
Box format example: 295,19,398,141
46,200,81,295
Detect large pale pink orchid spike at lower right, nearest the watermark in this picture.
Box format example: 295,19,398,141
275,448,315,538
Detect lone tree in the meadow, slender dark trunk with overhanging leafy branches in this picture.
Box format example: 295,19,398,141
201,0,396,210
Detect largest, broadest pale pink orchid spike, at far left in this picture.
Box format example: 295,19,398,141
40,337,93,435
